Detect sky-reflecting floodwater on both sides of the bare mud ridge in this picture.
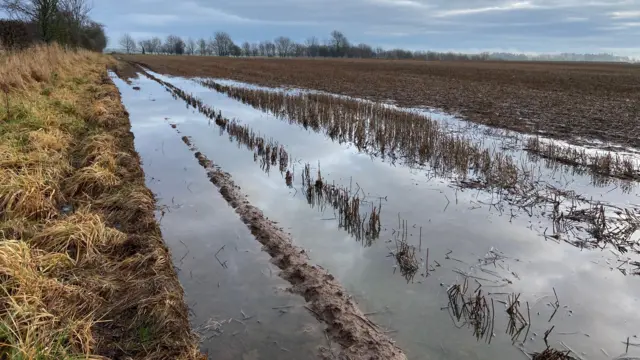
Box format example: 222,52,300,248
117,74,640,359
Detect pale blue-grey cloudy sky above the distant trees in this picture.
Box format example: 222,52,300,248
92,0,640,56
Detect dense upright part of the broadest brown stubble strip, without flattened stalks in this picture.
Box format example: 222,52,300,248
201,80,517,188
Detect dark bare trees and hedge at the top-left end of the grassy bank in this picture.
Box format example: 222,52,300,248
0,0,108,51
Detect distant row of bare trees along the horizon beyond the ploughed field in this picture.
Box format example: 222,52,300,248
119,30,631,62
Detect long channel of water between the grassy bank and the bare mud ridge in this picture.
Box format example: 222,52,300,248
113,74,327,360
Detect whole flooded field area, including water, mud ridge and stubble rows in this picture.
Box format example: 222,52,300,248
114,57,640,359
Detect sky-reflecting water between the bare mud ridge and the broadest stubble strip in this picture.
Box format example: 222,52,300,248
124,71,640,359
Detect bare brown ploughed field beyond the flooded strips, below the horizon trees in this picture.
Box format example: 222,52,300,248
125,55,640,147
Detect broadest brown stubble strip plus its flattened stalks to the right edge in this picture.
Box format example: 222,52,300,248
199,80,640,252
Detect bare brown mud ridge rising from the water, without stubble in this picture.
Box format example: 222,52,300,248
176,132,407,360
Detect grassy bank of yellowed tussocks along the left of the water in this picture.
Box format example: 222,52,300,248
0,46,199,359
